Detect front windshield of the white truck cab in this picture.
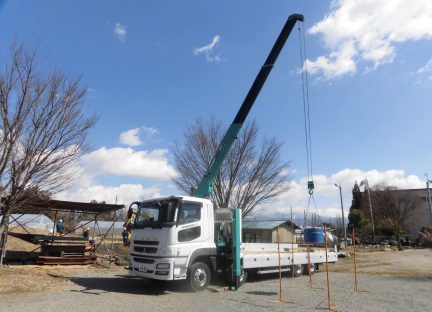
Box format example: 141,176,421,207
134,199,179,228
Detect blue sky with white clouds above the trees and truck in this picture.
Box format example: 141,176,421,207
0,0,432,216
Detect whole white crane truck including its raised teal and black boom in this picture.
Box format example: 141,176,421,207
129,14,337,291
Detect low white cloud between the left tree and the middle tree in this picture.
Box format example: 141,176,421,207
82,147,177,180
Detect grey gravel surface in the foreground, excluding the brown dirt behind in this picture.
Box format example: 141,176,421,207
0,266,432,312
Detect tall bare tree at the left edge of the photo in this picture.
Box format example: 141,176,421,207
0,45,95,265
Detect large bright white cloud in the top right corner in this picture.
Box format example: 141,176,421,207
306,0,432,80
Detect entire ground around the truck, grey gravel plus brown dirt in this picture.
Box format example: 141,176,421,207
0,249,432,312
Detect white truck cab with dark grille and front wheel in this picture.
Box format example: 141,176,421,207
129,196,221,288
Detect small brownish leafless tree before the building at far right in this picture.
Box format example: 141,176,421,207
371,184,420,249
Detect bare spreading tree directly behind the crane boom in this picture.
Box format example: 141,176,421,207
173,119,290,217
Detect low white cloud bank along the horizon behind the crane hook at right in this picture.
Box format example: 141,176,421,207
258,169,425,220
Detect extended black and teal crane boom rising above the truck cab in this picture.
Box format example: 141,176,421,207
193,14,304,198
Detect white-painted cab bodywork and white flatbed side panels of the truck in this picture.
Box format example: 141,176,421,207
129,196,337,286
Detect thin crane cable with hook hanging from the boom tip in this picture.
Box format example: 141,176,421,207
298,23,321,228
